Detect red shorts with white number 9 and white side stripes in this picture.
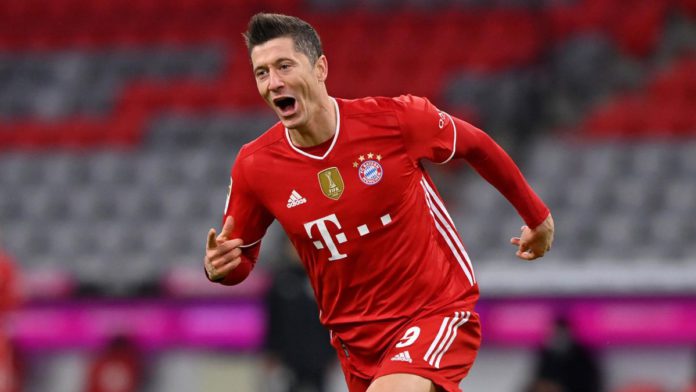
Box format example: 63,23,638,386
339,311,481,392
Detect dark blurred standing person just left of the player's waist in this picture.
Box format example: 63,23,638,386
266,241,335,392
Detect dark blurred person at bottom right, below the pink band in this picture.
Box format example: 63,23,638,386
528,317,603,392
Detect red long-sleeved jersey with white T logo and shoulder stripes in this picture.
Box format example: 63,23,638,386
224,96,548,377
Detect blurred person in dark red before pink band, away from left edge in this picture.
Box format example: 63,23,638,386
85,334,144,392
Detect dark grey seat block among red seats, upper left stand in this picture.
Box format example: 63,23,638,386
0,46,224,121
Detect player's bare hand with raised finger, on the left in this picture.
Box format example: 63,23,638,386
204,216,244,281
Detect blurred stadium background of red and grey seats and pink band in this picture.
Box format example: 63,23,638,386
0,0,696,392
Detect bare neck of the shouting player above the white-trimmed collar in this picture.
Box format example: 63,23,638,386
288,95,337,147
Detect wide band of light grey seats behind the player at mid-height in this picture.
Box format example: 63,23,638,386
0,140,696,294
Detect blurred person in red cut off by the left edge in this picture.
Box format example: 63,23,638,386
0,239,24,392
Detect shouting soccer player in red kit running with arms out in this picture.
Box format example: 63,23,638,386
204,14,553,392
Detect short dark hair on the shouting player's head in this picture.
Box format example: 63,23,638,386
244,12,324,64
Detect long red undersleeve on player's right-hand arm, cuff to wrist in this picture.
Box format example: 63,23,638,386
455,119,549,228
